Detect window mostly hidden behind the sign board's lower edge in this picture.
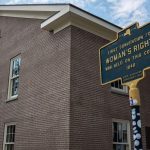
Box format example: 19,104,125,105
111,80,128,94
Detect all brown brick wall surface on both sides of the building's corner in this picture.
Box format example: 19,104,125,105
0,17,150,150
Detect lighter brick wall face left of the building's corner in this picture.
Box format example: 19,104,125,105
0,17,71,150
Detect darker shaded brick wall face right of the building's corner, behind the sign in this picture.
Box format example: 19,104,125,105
70,27,150,150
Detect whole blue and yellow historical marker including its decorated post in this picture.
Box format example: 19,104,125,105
99,23,150,150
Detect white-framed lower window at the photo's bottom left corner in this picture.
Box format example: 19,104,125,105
3,124,16,150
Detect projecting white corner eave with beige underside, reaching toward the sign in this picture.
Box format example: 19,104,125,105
41,5,121,41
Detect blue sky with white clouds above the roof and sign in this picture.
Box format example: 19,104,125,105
0,0,150,27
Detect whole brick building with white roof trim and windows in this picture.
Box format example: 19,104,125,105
0,4,150,150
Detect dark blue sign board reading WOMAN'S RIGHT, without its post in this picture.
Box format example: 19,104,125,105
99,23,150,84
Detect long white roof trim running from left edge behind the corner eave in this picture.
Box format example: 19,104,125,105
0,4,67,19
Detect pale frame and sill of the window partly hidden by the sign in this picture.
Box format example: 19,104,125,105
111,80,129,95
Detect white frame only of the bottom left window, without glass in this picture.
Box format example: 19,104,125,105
3,122,16,150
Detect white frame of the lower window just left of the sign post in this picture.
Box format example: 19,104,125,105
112,118,131,150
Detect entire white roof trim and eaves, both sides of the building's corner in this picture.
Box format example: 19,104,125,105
0,4,121,40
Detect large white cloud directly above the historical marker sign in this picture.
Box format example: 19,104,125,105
107,0,148,26
